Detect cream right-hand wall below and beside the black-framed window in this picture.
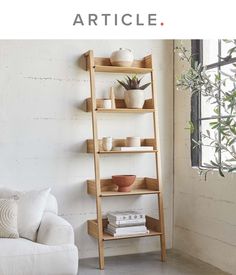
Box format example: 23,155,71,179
174,41,236,274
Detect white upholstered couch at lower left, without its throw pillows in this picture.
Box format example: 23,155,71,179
0,189,78,275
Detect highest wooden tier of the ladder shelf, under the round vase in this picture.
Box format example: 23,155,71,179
85,51,152,74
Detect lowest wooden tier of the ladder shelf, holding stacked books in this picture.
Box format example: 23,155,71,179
87,216,162,241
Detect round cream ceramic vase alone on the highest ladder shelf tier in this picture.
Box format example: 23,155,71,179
110,48,134,67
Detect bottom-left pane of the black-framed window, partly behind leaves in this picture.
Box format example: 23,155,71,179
201,119,218,166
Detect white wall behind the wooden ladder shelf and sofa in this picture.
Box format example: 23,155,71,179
0,40,173,257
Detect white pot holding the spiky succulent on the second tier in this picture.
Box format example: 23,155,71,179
125,89,145,109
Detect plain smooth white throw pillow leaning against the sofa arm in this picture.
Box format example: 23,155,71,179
14,188,51,241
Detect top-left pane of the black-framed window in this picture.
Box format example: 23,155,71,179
203,39,218,65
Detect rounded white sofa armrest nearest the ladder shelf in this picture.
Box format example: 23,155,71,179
37,212,74,245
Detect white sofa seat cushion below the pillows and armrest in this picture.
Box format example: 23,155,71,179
0,238,78,275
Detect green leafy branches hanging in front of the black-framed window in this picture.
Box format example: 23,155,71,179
176,40,236,177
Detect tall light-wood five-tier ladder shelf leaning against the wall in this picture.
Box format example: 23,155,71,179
84,50,166,269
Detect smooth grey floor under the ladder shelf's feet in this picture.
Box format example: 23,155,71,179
79,251,228,275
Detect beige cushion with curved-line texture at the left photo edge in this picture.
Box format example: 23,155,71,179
0,199,19,238
